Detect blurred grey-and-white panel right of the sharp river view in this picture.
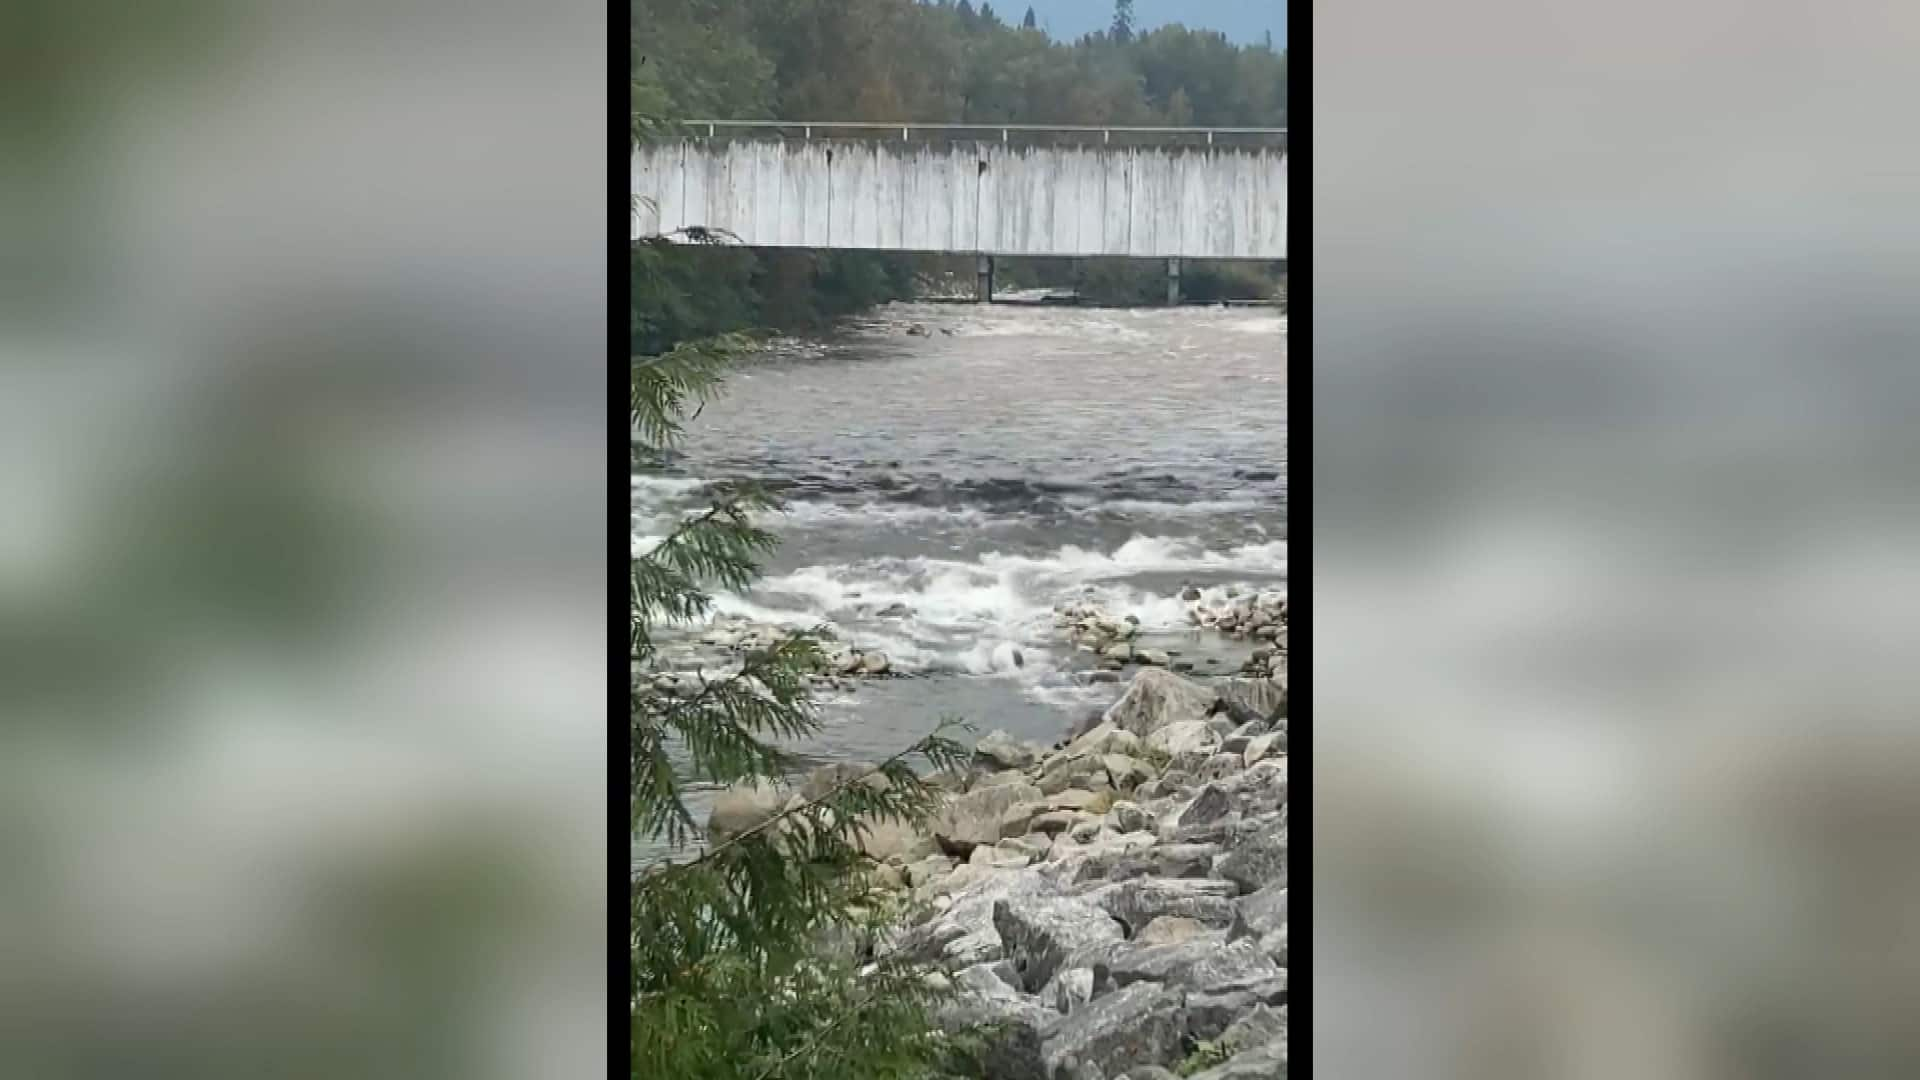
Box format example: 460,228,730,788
1311,0,1920,1080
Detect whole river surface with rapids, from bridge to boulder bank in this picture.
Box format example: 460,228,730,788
634,295,1286,849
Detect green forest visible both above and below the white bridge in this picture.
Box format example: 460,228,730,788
630,0,1286,332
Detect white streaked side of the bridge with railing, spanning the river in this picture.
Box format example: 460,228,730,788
632,121,1286,259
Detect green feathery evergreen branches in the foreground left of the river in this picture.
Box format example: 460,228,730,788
628,96,966,1080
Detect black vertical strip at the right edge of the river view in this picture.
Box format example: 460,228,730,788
1284,0,1313,1076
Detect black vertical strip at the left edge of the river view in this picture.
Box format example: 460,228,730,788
607,0,634,1076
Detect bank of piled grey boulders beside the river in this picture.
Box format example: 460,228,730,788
712,657,1286,1080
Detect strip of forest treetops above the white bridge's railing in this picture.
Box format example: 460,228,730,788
632,0,1286,127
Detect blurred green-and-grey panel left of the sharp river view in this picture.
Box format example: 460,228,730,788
0,0,618,1078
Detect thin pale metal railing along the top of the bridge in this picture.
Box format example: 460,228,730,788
672,119,1286,150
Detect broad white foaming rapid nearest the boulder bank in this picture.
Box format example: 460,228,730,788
714,536,1286,696
